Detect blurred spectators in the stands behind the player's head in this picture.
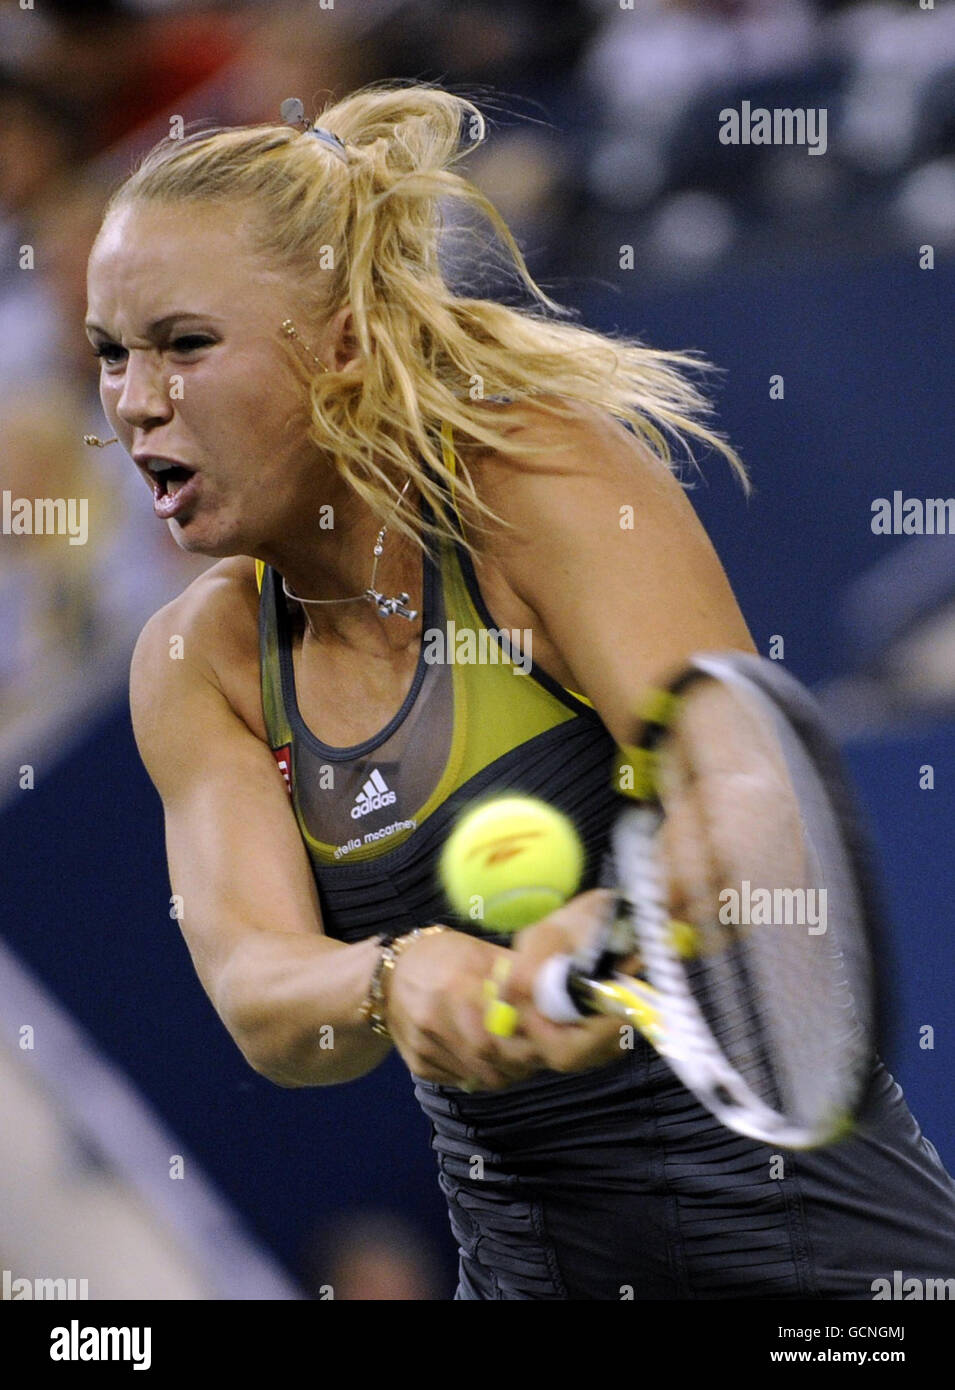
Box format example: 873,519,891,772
0,0,955,708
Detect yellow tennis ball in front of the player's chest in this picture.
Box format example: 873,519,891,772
439,795,584,931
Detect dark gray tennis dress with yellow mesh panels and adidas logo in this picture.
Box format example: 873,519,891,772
251,480,955,1300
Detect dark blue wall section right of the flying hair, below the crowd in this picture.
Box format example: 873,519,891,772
578,256,955,682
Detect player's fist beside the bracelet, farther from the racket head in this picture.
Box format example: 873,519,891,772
385,930,549,1091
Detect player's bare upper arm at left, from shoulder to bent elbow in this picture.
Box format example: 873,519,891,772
129,600,321,1006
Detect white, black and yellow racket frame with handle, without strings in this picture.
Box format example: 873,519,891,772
535,652,885,1150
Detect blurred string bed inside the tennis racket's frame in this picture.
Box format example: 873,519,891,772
658,682,869,1126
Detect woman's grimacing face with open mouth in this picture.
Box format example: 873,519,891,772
86,203,341,556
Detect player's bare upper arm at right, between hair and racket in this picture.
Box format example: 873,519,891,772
482,411,755,742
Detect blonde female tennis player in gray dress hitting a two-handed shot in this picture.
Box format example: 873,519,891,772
88,86,955,1300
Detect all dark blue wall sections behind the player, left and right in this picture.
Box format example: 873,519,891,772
3,259,955,1279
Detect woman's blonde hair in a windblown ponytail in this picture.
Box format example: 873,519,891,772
106,83,749,556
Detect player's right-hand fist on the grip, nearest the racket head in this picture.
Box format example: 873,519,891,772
500,888,624,1072
